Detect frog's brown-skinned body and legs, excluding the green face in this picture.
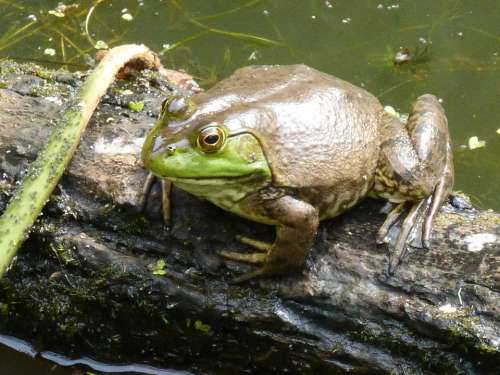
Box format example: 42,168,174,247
144,65,453,281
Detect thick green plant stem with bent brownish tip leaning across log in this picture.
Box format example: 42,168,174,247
0,44,157,278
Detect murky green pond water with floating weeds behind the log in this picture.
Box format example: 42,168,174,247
0,0,500,374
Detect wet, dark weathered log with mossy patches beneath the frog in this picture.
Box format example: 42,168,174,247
0,61,500,374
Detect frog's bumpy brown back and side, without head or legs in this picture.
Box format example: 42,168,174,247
191,65,383,216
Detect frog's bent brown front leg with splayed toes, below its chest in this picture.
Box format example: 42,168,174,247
220,195,319,282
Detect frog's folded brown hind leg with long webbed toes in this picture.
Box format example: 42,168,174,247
373,95,453,270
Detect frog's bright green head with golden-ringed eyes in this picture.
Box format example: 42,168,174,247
142,97,271,185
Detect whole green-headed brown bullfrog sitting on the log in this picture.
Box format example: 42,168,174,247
142,65,453,281
